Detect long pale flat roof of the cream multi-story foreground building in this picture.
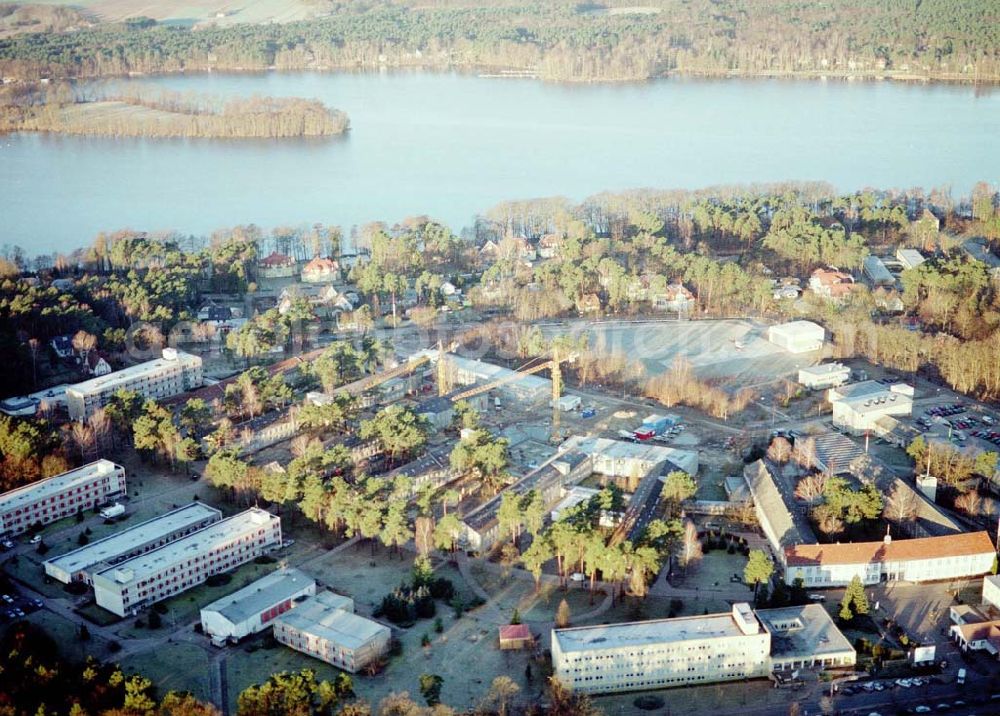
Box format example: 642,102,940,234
552,612,747,653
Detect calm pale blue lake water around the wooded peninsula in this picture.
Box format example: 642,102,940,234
0,73,1000,254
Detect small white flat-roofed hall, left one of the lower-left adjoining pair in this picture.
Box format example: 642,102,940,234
201,569,316,644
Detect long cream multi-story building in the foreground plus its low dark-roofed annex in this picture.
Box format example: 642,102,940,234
552,603,857,694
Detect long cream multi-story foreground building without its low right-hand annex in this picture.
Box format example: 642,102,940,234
552,603,771,694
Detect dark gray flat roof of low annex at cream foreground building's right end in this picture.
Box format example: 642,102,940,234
756,604,854,659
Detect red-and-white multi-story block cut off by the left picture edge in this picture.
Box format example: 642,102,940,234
0,460,125,536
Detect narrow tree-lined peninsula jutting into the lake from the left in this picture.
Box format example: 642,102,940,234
0,84,350,139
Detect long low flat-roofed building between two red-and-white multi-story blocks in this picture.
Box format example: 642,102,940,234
42,502,222,584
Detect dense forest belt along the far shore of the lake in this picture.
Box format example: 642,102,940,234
0,0,1000,82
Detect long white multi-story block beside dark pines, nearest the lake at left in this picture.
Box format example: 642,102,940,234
66,348,202,420
